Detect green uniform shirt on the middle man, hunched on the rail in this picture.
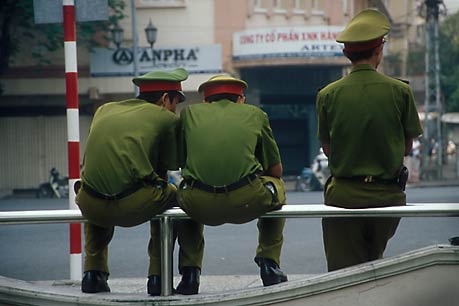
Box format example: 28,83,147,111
180,100,280,186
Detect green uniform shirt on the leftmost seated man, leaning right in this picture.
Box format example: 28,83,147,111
82,99,179,194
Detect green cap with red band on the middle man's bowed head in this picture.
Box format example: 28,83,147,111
198,75,248,98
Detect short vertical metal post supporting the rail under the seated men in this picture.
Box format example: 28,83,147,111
159,216,174,296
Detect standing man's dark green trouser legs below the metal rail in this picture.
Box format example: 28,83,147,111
322,217,400,271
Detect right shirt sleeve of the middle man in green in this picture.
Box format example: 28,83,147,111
255,112,281,170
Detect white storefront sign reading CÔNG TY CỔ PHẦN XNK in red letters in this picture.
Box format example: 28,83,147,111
233,26,344,60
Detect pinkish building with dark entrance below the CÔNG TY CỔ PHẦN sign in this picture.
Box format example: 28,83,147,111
215,0,388,175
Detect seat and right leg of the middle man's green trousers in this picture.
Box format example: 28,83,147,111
177,176,286,265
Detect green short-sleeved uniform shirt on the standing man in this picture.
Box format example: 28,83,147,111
316,65,422,202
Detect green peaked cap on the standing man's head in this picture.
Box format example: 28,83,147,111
336,9,390,52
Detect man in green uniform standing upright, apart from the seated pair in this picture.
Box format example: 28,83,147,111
316,9,422,271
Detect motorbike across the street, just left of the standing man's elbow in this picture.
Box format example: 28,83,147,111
295,148,330,192
